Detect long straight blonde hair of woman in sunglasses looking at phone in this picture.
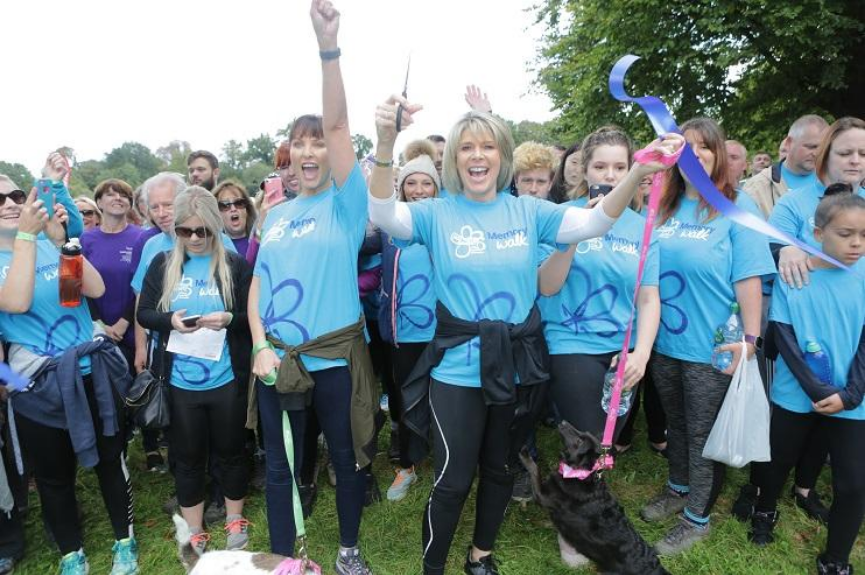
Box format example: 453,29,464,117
159,186,234,311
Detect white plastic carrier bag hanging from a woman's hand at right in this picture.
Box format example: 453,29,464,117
703,343,771,467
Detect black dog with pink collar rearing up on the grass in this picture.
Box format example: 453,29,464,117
520,421,669,575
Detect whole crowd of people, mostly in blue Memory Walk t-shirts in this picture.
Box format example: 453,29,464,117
0,0,865,575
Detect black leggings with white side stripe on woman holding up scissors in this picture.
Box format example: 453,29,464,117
423,380,545,575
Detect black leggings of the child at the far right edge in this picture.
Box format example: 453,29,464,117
753,405,865,564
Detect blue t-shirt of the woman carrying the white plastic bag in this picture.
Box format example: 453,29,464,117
655,192,775,363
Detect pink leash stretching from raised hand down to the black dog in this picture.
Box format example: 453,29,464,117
572,141,684,480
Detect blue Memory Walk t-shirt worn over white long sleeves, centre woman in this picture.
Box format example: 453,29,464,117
408,191,567,387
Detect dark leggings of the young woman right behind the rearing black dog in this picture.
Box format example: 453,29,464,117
550,352,628,440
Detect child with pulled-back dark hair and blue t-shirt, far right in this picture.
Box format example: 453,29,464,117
750,193,865,573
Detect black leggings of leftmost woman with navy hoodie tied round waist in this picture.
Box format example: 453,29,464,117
15,376,133,555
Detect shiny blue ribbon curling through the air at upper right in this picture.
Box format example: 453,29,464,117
610,54,852,271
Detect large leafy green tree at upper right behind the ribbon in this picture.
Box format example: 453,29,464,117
536,0,865,149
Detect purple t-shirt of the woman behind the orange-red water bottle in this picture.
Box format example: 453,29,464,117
81,225,143,348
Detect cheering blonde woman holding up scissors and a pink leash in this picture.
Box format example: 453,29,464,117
369,92,682,575
